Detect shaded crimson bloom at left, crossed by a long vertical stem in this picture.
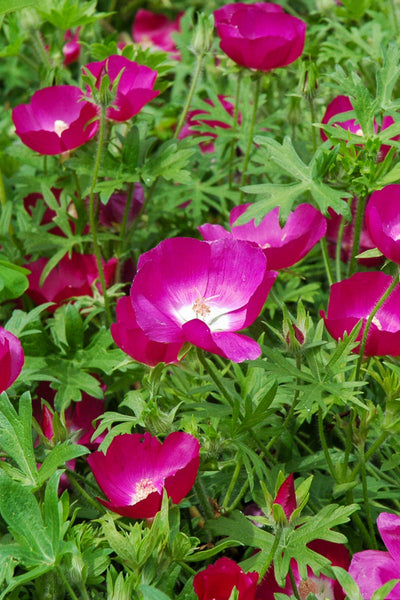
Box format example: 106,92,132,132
25,252,117,311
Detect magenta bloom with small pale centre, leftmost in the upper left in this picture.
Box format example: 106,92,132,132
12,85,99,155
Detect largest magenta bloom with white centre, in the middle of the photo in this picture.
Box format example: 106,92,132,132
131,238,277,362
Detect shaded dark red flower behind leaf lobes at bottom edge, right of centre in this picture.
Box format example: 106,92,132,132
255,540,350,600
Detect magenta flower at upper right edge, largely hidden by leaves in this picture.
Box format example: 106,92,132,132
321,96,400,160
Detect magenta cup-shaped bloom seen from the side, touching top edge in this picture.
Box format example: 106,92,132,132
214,2,306,71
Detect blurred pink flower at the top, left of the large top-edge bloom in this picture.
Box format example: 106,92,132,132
132,8,183,57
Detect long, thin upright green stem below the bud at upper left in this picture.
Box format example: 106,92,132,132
89,106,112,325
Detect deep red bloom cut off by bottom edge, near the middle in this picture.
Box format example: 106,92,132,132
193,557,258,600
